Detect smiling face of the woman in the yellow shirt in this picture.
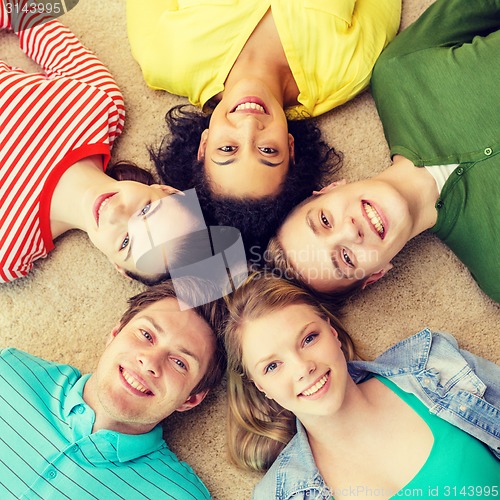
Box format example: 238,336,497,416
198,82,293,198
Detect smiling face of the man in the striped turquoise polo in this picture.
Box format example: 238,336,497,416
84,298,215,434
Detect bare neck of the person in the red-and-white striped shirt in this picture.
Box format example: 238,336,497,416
50,156,113,238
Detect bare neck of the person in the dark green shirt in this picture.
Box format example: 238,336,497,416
375,155,439,239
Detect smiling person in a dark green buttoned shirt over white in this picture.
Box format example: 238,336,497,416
268,0,500,302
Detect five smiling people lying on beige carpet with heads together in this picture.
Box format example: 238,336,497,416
0,0,500,500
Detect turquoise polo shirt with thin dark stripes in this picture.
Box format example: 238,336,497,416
0,349,210,500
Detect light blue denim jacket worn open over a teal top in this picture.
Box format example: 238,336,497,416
253,329,500,500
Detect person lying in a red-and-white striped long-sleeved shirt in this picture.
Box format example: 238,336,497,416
0,2,201,284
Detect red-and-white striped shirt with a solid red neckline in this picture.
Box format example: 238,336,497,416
0,9,125,282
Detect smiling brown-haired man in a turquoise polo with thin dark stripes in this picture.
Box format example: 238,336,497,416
0,278,224,500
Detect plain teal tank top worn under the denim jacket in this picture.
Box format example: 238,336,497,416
376,376,500,499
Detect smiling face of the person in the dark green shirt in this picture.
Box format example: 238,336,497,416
278,179,413,292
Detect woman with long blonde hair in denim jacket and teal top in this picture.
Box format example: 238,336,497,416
225,274,500,500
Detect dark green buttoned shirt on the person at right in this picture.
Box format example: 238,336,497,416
371,0,500,302
